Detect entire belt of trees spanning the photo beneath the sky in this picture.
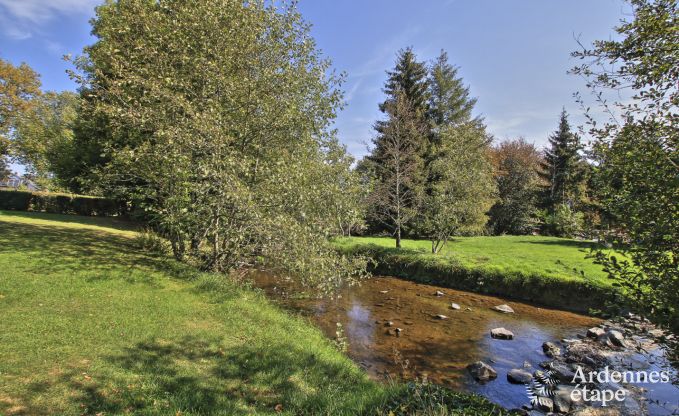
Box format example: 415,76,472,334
0,0,679,326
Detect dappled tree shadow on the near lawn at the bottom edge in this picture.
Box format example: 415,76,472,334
57,337,382,415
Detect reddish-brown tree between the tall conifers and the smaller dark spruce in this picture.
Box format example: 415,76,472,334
489,138,542,234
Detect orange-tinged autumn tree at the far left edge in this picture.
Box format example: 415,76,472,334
0,58,40,178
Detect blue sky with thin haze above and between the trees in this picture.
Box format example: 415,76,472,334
0,0,629,169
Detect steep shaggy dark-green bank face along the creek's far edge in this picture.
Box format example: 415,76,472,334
340,244,622,313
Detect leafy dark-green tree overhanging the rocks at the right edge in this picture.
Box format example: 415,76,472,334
572,0,679,330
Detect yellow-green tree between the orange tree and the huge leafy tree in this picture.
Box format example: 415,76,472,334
12,91,79,189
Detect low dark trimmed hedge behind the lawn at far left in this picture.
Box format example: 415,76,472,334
0,189,127,217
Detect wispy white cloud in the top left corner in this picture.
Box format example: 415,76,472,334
0,0,101,40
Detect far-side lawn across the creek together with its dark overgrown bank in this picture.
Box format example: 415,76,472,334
335,236,615,312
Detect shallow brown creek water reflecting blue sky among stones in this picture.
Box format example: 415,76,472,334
253,273,676,414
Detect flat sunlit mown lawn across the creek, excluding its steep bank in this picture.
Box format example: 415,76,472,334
335,236,612,287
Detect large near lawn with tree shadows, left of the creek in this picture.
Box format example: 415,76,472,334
0,211,510,415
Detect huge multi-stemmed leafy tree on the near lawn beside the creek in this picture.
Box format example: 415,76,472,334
71,0,364,289
